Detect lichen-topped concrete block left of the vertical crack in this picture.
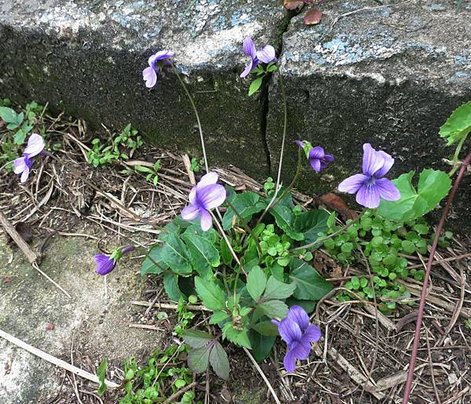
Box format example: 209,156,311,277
0,0,285,175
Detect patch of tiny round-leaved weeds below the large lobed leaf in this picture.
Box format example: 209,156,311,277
324,211,452,312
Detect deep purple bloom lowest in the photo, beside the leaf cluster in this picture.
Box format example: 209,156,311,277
272,306,322,372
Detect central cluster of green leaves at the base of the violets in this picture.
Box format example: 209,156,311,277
141,190,332,372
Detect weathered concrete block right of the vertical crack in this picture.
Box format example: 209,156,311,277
267,0,471,221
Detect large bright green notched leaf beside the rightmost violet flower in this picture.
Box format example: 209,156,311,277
378,168,451,222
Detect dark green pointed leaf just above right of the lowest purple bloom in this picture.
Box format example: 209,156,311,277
289,258,332,300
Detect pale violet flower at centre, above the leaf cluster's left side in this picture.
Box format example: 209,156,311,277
182,173,226,231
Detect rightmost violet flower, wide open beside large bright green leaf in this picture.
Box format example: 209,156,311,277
338,143,401,208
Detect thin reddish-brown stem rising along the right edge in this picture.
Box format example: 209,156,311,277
402,153,471,404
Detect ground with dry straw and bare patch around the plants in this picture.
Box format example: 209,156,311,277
0,110,471,404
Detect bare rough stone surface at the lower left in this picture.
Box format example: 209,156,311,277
0,236,160,404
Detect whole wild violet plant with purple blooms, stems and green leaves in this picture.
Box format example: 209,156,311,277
135,38,471,379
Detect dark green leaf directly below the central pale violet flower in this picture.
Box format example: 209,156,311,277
182,227,221,277
